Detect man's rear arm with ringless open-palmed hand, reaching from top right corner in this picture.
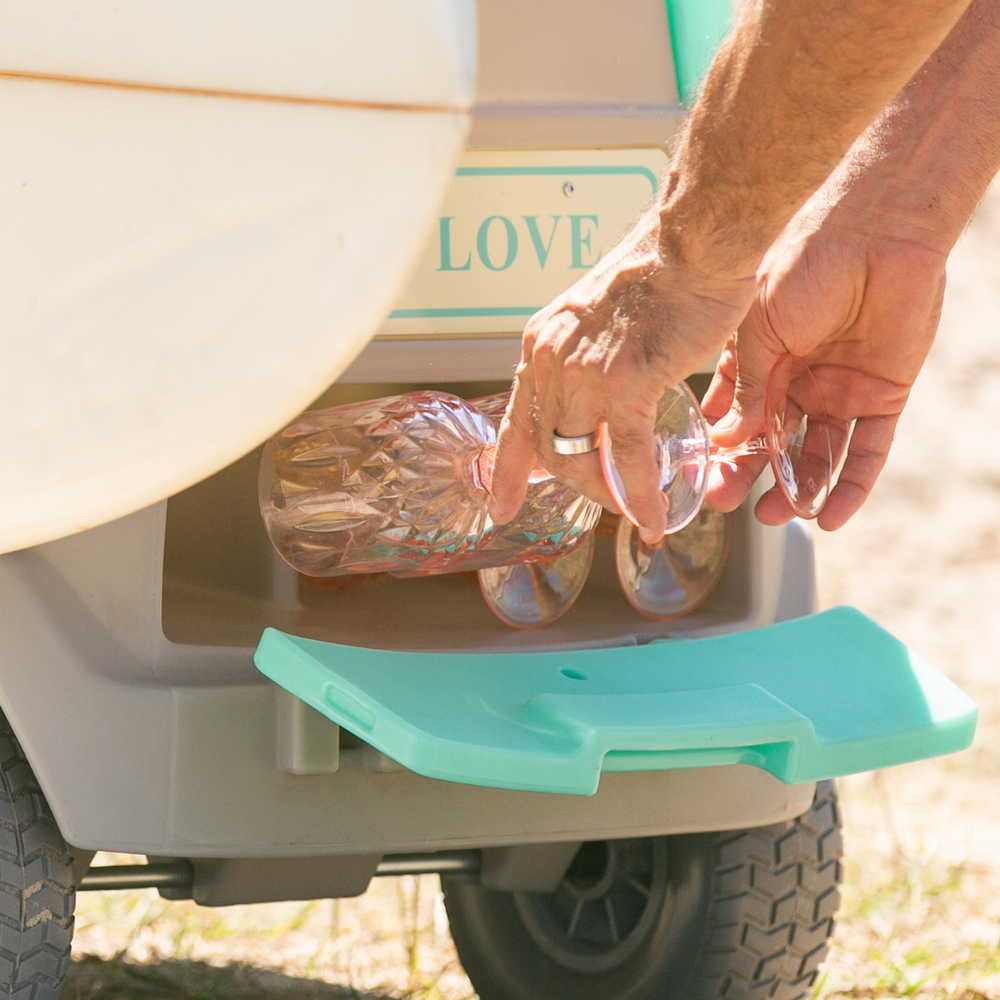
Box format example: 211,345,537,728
704,0,1000,530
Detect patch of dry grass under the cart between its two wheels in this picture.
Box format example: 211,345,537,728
66,859,473,1000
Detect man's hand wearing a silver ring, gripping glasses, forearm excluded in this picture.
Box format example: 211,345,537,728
490,212,754,541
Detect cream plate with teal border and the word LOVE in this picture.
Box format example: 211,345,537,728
379,149,666,338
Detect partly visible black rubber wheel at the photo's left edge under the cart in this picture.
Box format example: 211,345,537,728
0,716,76,1000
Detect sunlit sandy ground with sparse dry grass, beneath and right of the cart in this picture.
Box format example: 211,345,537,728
69,192,1000,1000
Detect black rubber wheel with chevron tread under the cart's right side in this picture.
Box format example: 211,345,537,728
441,782,843,1000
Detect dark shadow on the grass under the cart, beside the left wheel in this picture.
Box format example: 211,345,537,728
61,955,395,1000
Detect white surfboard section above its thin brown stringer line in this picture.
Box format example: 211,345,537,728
0,0,475,107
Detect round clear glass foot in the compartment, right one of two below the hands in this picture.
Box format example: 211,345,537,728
615,507,732,621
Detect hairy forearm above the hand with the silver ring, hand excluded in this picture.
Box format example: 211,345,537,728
660,0,968,278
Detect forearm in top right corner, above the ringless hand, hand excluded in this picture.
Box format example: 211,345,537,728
822,0,1000,254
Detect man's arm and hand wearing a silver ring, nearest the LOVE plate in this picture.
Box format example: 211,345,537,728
491,0,967,537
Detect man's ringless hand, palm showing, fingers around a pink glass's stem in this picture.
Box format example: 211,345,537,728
703,204,946,530
